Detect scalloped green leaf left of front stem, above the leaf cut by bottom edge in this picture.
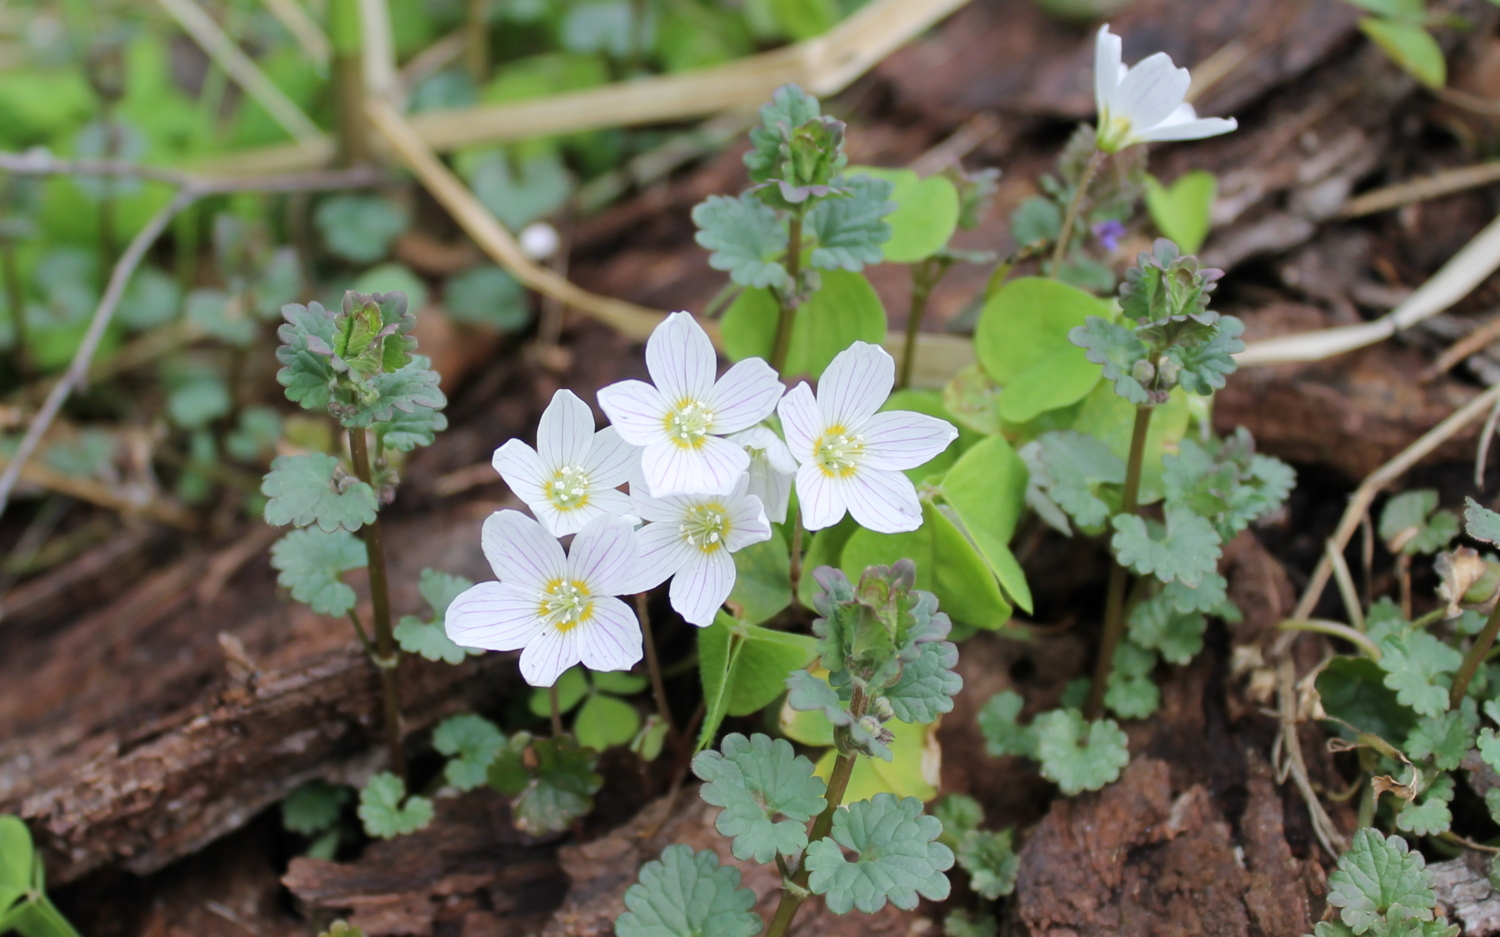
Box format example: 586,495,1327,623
693,733,827,862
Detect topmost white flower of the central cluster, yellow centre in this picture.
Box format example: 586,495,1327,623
599,312,783,498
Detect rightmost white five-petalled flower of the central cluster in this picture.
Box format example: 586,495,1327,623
779,342,959,534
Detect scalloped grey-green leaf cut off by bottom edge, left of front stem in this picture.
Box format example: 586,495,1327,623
615,843,761,937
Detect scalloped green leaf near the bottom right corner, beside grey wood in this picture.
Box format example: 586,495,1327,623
1328,828,1437,934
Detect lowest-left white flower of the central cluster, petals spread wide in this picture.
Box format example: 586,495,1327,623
444,511,641,687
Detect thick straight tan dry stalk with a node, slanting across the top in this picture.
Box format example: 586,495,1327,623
190,0,968,175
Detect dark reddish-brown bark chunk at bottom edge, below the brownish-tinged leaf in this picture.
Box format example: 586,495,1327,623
282,787,567,937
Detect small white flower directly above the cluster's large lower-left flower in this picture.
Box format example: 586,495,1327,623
495,390,636,537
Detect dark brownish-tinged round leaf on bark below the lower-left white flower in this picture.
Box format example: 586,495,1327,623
489,732,605,835
